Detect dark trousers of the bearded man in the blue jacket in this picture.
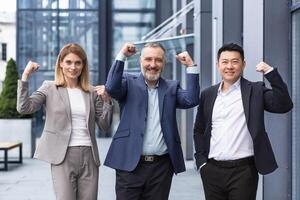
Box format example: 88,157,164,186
115,156,174,200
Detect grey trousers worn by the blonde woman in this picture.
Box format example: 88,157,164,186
51,146,99,200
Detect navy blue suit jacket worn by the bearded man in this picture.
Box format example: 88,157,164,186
104,60,200,173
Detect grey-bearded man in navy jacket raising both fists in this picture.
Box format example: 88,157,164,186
104,43,200,200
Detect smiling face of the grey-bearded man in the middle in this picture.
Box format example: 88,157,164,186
140,47,165,86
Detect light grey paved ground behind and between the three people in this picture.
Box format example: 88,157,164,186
0,139,204,200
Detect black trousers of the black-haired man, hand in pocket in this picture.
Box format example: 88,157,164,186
200,160,258,200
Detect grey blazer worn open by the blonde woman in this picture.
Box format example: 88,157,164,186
17,80,112,166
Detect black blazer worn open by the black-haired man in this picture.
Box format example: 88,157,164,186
194,69,293,174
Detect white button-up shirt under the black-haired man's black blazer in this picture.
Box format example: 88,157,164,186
208,79,254,160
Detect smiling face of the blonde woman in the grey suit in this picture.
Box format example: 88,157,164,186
60,53,83,86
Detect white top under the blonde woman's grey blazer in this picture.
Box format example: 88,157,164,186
67,88,92,146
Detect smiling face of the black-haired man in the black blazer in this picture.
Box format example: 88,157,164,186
217,51,245,85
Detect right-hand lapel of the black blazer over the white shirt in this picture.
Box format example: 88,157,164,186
241,77,252,124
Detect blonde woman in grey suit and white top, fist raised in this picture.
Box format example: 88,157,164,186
17,43,112,200
